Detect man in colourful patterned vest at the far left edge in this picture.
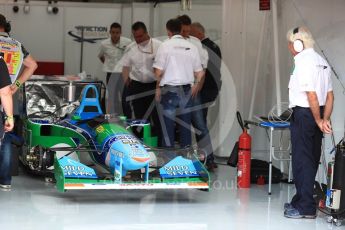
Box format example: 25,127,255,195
0,14,37,189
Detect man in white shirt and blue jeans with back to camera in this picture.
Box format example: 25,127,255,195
153,19,203,147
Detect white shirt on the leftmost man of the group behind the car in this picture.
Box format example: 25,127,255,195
98,37,132,73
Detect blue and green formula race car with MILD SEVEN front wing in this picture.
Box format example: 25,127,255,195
20,84,210,191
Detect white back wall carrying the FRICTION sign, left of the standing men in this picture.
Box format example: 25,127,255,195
0,1,122,79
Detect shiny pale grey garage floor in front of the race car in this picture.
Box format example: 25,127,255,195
0,166,336,230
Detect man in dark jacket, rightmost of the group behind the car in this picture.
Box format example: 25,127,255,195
190,22,222,171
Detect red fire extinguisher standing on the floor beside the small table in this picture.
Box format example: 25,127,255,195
237,113,252,188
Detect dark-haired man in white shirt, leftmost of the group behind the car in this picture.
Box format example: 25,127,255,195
98,22,132,116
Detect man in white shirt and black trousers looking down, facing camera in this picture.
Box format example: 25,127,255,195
121,21,162,142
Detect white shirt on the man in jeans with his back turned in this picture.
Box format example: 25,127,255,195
153,35,203,86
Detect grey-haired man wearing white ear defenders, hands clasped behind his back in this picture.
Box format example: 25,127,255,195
284,27,334,219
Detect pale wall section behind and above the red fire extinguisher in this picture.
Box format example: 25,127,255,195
219,0,275,158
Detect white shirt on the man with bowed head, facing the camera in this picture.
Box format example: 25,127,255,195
121,38,162,83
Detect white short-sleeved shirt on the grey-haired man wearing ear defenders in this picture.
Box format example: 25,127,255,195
289,48,333,108
